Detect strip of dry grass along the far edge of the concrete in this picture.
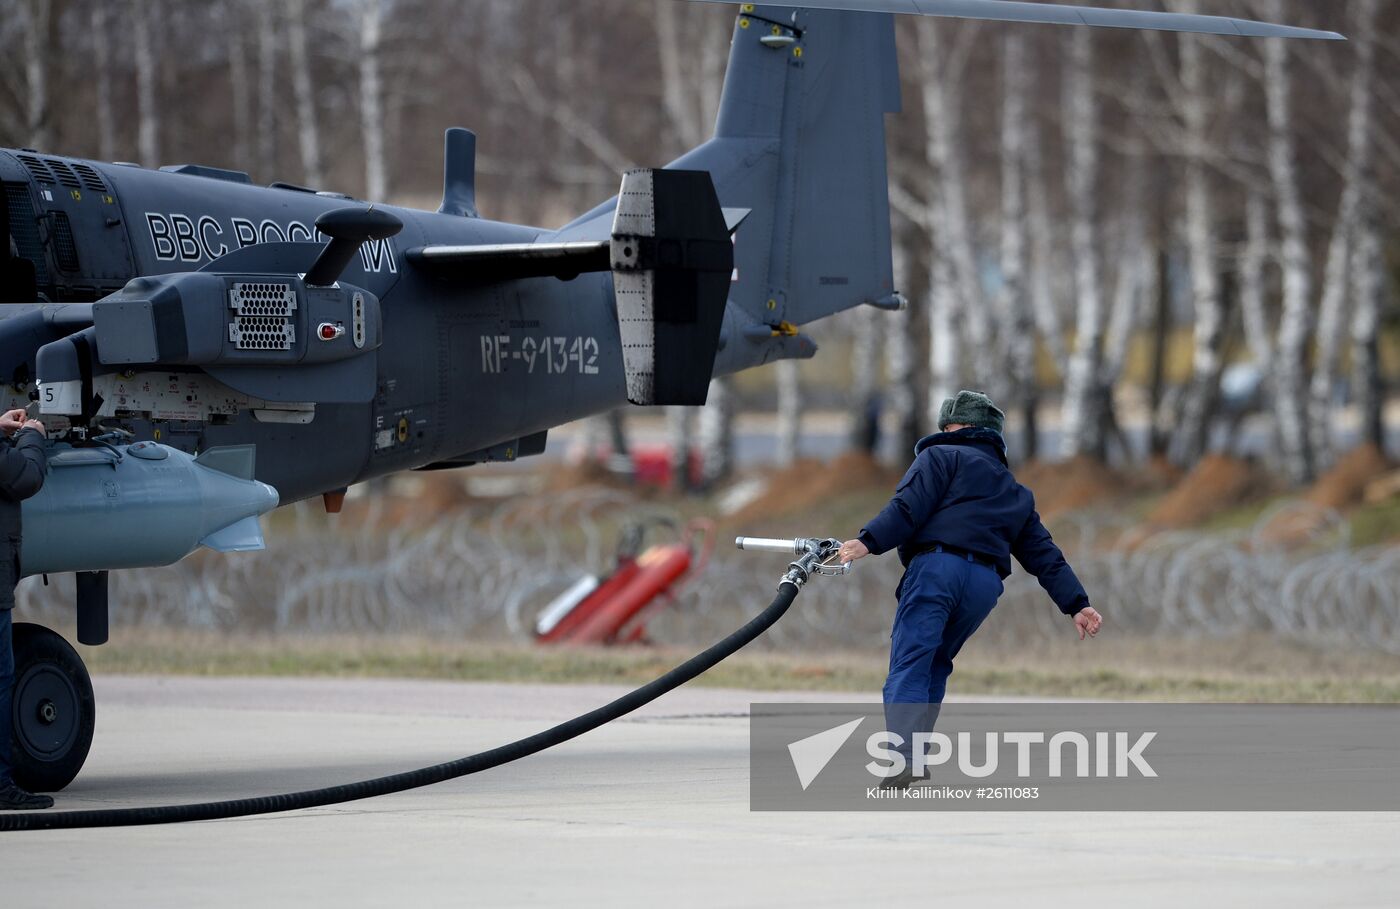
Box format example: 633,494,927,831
68,632,1400,703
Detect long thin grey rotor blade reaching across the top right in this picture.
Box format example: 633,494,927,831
680,0,1345,41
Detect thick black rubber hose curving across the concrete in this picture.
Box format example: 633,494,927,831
0,581,798,831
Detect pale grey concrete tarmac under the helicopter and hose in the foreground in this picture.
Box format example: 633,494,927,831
0,676,1400,909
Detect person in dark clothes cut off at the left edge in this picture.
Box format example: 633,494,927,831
0,410,53,811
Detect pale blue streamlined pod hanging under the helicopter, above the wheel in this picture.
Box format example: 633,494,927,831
20,441,277,576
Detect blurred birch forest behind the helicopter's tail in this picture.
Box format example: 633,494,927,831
0,0,1400,485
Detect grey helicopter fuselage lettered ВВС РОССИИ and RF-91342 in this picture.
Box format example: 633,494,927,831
0,151,626,503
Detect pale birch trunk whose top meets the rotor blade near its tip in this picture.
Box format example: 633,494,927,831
1264,38,1315,483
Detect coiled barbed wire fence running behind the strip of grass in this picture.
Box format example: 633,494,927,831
18,489,1400,653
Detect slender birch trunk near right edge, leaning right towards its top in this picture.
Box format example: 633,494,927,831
1309,0,1376,469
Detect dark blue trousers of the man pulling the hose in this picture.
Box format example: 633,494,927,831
885,552,1002,759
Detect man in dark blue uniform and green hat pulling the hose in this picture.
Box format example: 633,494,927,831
841,391,1103,786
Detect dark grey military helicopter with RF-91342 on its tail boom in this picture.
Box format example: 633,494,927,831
0,0,1341,791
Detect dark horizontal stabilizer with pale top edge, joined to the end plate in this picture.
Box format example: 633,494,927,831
407,241,612,284
